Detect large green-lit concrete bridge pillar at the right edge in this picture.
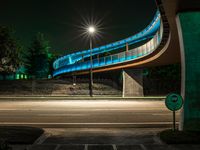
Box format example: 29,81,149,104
177,12,200,130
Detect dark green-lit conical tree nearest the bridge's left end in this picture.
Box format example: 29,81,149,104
23,33,50,79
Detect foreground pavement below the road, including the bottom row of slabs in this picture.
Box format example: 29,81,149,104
12,128,200,150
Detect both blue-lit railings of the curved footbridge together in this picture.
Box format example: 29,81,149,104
53,11,162,76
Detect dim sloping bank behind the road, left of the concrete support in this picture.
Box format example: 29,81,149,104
0,79,122,96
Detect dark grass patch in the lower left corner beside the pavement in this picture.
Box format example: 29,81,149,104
0,126,44,144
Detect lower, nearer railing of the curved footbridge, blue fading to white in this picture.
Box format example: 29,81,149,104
53,22,163,76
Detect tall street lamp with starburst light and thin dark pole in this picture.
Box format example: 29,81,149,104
88,26,96,97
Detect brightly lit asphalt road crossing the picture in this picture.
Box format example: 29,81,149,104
0,100,179,127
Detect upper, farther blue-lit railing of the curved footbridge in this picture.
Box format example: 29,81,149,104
53,11,161,70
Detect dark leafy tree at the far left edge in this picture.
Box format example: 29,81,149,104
0,26,22,77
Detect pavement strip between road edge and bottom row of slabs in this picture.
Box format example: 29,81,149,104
43,128,163,145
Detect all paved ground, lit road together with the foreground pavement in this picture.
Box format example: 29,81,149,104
0,97,195,150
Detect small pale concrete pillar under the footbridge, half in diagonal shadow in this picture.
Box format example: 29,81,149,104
122,69,144,97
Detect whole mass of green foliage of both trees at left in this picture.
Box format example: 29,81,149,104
0,25,56,79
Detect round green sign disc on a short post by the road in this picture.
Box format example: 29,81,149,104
165,93,183,111
